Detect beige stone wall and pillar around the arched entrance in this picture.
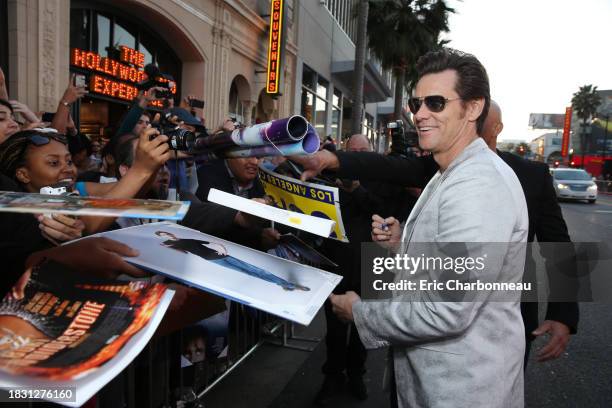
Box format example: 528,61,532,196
8,0,296,127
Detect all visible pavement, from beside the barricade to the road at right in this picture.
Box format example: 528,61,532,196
204,195,612,408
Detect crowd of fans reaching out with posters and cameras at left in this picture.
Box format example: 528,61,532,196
0,62,426,404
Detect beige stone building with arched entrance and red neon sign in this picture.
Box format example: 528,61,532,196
0,0,297,139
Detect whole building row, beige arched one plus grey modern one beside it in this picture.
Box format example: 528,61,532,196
0,0,406,151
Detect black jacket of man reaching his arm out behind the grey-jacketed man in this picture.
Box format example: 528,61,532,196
336,151,578,336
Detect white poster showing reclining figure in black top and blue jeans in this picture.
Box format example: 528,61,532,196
97,222,342,325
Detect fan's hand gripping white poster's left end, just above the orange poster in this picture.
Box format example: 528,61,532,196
11,238,147,299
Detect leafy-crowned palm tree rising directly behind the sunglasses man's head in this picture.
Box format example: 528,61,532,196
367,0,455,120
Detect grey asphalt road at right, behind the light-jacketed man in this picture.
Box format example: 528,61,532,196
525,194,612,407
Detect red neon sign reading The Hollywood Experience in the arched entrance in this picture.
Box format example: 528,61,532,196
70,45,176,107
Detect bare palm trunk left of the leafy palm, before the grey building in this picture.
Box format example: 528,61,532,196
351,0,369,134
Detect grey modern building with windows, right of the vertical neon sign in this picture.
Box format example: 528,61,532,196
294,0,393,150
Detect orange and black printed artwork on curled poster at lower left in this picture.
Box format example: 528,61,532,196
0,270,166,381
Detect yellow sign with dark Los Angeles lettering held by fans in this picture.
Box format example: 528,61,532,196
259,167,348,242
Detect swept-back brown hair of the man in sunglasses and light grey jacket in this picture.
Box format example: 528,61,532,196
417,48,491,135
